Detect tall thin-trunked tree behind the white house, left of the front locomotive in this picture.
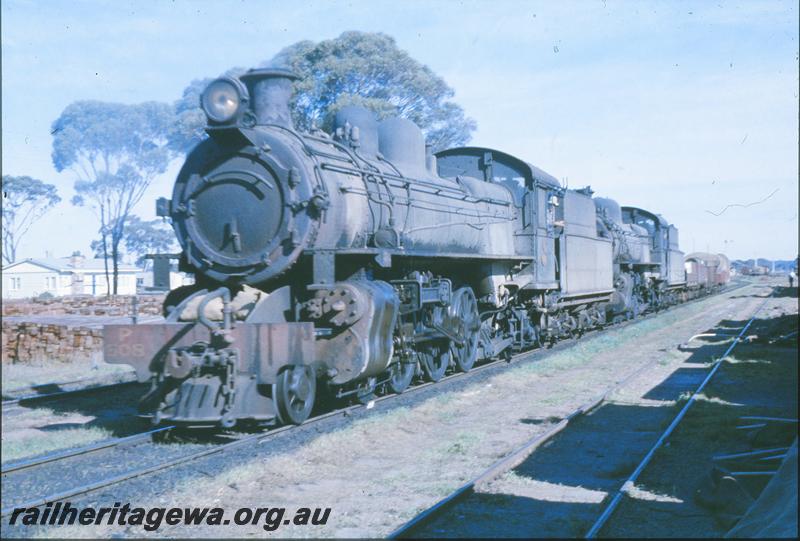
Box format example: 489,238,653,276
52,101,174,295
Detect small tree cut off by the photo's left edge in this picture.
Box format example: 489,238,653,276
2,175,61,263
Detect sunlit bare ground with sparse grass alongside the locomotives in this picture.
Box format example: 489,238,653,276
0,278,776,536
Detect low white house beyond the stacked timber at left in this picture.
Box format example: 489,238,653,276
3,252,139,299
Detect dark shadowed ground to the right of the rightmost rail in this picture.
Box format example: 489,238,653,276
600,306,798,537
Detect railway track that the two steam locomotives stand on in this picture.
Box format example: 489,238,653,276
0,284,747,517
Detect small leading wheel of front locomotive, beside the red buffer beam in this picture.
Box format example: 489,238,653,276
272,365,317,425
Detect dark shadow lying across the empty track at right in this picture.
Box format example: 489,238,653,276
415,315,797,537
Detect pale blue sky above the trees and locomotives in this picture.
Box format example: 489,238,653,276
2,0,798,259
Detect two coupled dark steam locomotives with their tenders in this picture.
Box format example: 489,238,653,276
104,69,724,427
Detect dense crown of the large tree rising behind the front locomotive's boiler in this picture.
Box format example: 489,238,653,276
169,32,476,152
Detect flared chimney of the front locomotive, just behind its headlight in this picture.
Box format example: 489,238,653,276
239,68,298,129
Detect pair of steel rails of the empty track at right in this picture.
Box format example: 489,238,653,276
388,285,769,539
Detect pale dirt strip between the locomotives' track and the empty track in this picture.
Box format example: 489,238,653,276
20,278,788,537
